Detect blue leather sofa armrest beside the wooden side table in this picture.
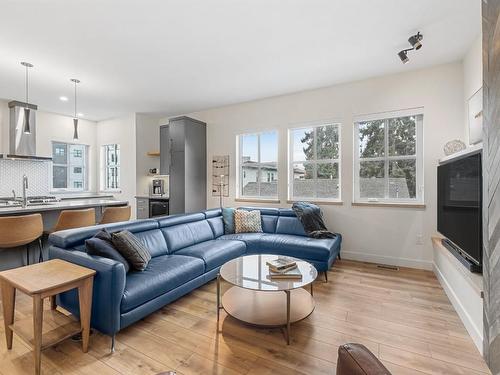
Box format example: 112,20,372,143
49,246,125,335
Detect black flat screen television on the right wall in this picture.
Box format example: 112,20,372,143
438,153,483,272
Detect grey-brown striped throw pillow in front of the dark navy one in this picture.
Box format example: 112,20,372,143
111,230,151,271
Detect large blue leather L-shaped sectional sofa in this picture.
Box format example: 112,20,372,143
49,207,342,348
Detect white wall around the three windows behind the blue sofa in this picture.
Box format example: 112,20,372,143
175,62,465,269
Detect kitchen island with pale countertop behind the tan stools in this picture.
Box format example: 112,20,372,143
0,195,128,270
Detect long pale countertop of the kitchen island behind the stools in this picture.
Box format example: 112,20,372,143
0,198,128,216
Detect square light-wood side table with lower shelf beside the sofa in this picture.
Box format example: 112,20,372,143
0,259,96,375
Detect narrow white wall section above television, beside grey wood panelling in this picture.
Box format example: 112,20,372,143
463,35,483,144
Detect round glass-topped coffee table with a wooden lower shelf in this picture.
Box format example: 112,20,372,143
217,254,318,344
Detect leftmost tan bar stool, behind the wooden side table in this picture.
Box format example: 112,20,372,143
0,214,43,265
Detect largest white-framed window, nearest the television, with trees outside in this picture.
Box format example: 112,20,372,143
354,109,423,203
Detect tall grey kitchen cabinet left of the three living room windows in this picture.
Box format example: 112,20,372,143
160,116,207,214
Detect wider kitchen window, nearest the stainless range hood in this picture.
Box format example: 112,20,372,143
52,142,89,190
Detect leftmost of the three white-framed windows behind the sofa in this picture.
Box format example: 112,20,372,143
237,130,278,199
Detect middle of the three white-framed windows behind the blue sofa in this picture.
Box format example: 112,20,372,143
288,123,341,200
